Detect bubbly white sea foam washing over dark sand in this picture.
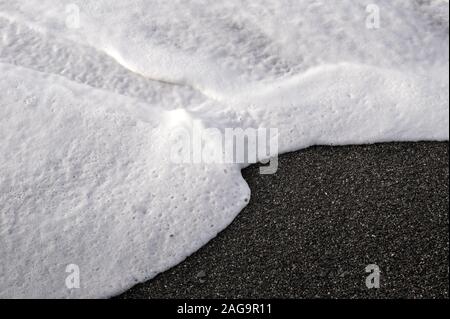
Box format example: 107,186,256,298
0,0,449,298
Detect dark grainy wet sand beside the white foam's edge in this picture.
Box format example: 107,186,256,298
119,143,449,298
